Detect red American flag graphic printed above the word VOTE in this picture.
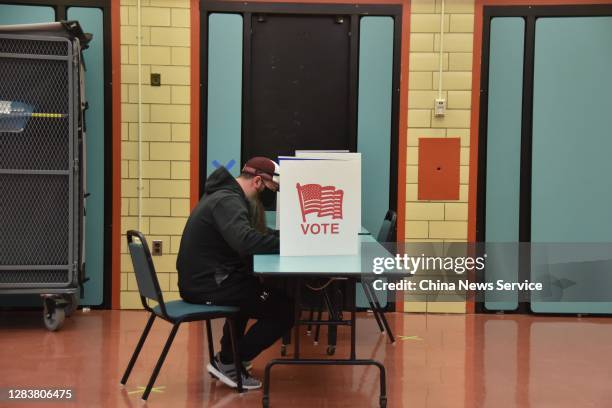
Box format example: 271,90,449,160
295,183,344,222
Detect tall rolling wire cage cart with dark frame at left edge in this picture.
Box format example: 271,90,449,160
0,21,91,330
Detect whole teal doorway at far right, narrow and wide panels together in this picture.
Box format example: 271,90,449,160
479,8,612,313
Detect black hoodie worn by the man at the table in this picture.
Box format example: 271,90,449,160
176,167,279,303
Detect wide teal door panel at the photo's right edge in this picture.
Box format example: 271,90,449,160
531,17,612,313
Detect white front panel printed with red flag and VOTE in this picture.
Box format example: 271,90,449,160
277,157,361,256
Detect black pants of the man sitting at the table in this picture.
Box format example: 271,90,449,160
215,286,295,363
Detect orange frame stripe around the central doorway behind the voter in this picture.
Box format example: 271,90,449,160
190,0,410,311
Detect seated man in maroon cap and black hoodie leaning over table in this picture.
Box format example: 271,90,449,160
176,157,294,389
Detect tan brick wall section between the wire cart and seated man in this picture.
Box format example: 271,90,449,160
121,0,191,309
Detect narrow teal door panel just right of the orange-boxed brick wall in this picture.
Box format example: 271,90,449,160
485,17,525,310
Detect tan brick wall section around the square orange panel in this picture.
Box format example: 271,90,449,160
404,0,474,313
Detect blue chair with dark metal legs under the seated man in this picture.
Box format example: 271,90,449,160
121,230,242,401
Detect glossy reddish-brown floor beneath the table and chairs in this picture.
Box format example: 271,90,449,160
0,311,612,408
